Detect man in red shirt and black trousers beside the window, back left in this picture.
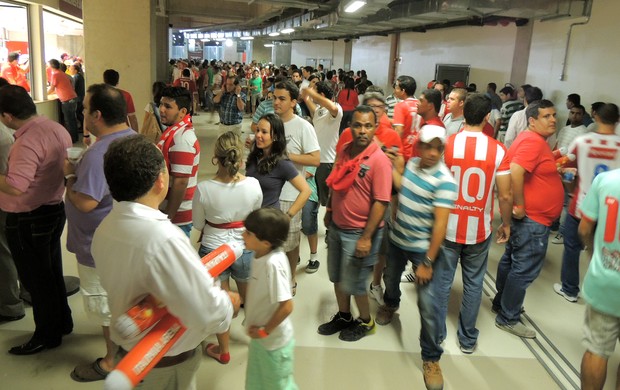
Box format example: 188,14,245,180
47,59,78,143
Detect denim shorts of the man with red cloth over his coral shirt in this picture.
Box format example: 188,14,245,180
327,223,383,296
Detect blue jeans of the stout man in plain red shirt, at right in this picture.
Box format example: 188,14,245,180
493,217,551,325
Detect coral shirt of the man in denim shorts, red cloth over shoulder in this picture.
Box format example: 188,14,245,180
332,142,392,229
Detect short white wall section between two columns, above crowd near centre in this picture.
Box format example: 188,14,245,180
351,36,391,90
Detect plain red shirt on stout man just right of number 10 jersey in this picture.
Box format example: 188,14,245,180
508,130,564,226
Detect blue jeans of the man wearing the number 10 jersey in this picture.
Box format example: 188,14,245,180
436,236,491,348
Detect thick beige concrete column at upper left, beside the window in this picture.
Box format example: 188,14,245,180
82,0,155,125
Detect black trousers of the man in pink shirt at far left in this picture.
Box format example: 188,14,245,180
6,202,73,345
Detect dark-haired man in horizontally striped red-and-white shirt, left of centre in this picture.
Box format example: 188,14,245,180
157,87,200,237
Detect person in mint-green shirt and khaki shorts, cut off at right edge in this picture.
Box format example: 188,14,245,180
579,169,620,390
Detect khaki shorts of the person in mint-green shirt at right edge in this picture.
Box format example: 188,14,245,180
582,304,620,359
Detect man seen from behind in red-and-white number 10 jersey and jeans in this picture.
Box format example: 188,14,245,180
437,94,512,354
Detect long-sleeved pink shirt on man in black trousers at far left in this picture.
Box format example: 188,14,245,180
0,116,72,213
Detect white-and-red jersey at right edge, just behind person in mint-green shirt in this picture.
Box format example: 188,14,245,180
568,133,620,218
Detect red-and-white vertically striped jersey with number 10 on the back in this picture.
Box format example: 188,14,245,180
444,130,510,244
